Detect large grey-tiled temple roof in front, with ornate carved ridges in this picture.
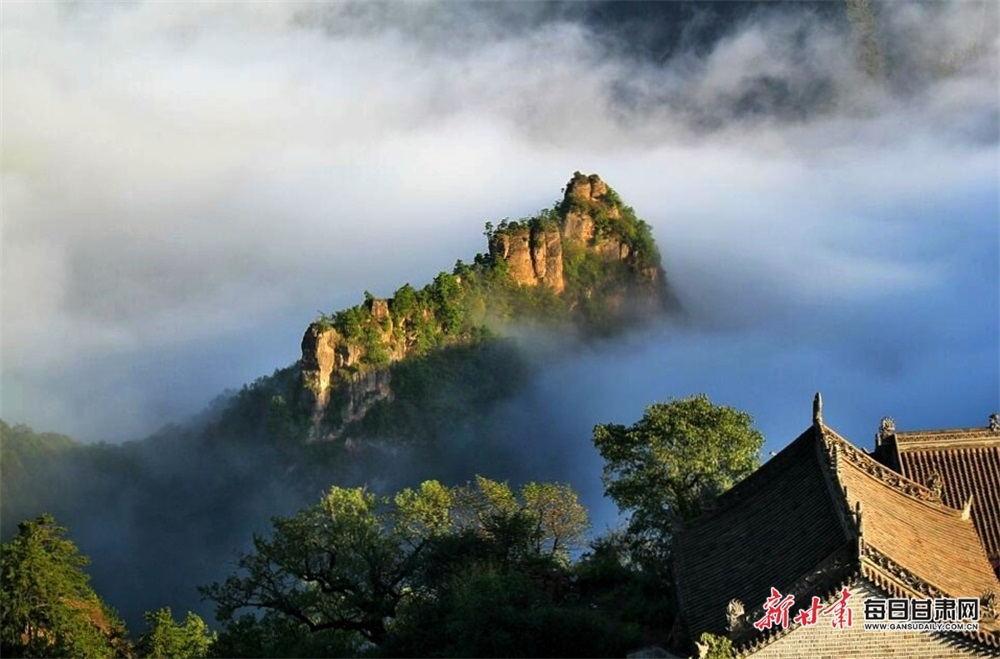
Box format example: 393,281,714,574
674,419,1000,644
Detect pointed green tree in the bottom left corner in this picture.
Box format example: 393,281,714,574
0,515,131,657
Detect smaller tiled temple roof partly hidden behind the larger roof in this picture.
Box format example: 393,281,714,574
876,422,1000,575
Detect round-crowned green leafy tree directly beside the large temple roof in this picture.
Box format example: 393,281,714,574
594,395,764,540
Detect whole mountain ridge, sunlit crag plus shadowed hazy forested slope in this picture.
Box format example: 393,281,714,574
0,173,675,624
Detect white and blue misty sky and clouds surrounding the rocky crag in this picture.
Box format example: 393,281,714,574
0,2,1000,445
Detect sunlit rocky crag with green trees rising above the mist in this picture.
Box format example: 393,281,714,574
299,172,670,437
